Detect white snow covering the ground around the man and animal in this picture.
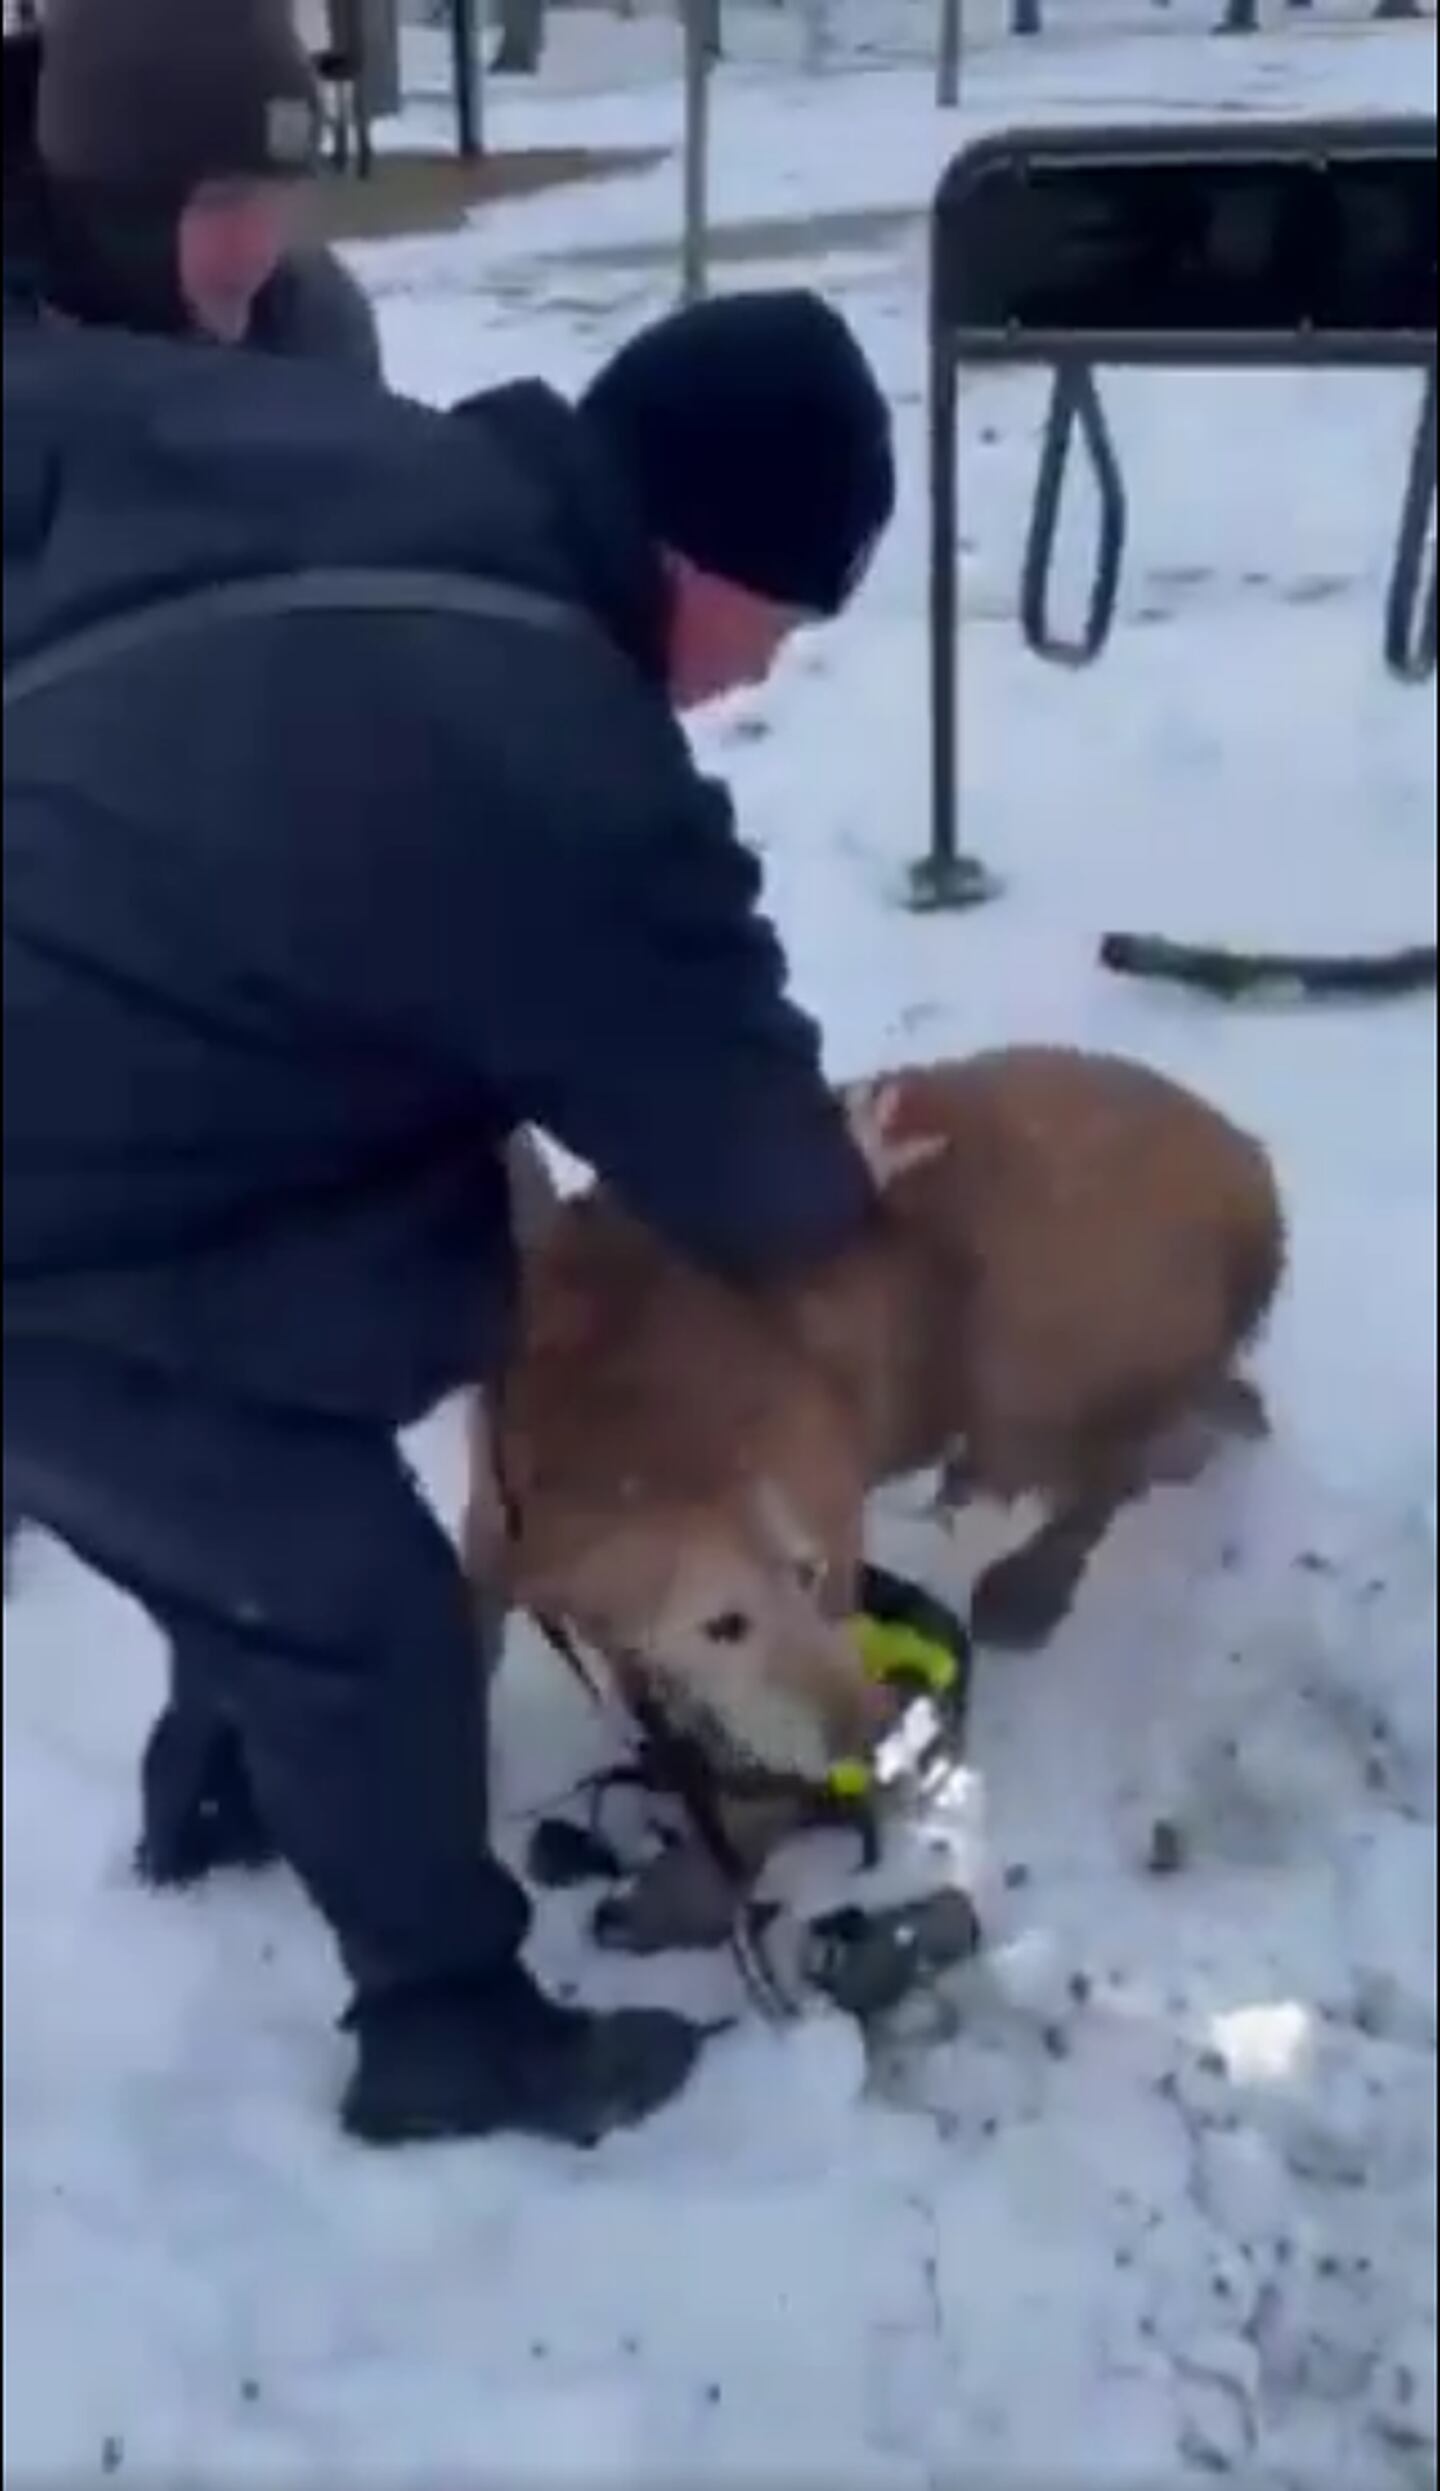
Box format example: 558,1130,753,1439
5,9,1435,2491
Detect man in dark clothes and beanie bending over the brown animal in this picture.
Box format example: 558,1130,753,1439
2,272,894,2142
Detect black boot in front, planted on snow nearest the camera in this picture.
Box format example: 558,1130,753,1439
341,1965,708,2145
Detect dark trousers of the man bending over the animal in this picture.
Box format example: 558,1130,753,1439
5,1338,528,1995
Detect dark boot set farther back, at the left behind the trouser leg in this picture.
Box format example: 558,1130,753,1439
135,1704,279,1886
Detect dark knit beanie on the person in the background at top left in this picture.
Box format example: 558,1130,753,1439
35,0,319,202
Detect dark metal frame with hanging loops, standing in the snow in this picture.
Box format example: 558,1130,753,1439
909,117,1438,909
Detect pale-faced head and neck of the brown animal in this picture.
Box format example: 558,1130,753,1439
498,1196,884,1779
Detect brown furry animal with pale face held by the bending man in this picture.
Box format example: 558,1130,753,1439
473,1046,1283,1776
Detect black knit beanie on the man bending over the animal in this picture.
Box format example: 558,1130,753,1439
580,291,894,615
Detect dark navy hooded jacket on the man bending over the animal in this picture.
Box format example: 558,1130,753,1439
2,319,872,1425
